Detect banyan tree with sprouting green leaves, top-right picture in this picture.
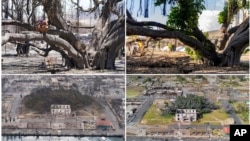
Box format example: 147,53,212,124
126,0,249,67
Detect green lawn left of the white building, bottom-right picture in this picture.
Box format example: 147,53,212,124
142,104,174,125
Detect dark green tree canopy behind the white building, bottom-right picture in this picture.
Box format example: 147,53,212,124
165,94,218,116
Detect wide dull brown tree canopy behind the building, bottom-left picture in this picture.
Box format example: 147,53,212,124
23,88,101,114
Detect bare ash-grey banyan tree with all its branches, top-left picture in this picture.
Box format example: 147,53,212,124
2,0,125,70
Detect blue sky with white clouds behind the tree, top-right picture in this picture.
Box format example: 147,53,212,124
126,0,225,32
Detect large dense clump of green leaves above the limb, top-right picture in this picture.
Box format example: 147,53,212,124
167,0,205,31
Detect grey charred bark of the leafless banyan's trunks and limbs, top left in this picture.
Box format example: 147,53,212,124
2,0,125,69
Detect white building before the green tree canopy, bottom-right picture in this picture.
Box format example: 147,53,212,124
175,109,197,122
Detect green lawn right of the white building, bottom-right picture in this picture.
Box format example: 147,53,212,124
194,109,229,125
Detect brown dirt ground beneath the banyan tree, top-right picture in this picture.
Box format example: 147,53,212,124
127,50,250,74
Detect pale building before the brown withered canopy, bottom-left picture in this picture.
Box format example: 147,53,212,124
50,104,71,116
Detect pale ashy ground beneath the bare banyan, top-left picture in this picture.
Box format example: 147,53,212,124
1,44,125,74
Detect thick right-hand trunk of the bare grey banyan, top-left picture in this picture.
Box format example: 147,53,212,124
93,16,125,70
